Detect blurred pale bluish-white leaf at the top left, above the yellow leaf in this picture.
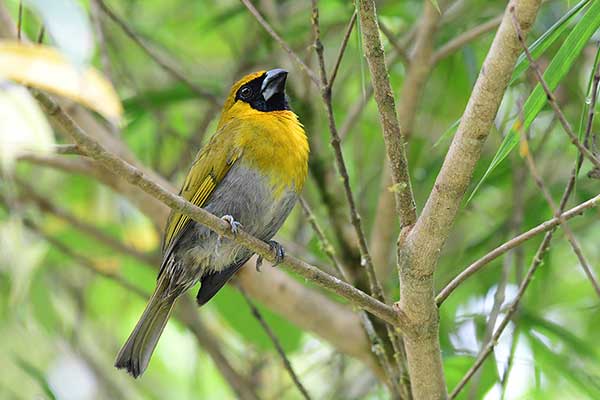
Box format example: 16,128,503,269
25,0,94,66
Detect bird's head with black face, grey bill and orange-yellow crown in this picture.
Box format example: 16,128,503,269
221,68,290,123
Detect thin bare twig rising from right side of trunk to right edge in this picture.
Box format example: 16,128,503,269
435,194,600,306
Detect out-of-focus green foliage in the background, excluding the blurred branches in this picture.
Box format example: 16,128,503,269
0,0,600,399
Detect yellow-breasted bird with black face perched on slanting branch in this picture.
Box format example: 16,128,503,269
115,68,309,378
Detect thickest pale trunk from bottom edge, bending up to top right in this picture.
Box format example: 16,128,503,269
398,0,541,399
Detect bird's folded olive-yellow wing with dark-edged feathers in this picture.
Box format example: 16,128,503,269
162,126,242,259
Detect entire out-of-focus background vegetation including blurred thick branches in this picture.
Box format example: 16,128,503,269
0,0,600,399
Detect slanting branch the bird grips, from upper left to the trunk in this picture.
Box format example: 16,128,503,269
34,91,405,329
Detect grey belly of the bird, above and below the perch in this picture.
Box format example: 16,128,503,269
174,162,297,280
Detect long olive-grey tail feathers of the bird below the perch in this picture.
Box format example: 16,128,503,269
115,285,177,378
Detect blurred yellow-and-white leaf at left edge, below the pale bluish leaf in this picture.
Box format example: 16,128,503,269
0,41,122,122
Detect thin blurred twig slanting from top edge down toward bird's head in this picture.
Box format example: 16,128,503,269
96,0,219,104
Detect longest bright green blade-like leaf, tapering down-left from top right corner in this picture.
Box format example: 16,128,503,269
467,1,600,203
